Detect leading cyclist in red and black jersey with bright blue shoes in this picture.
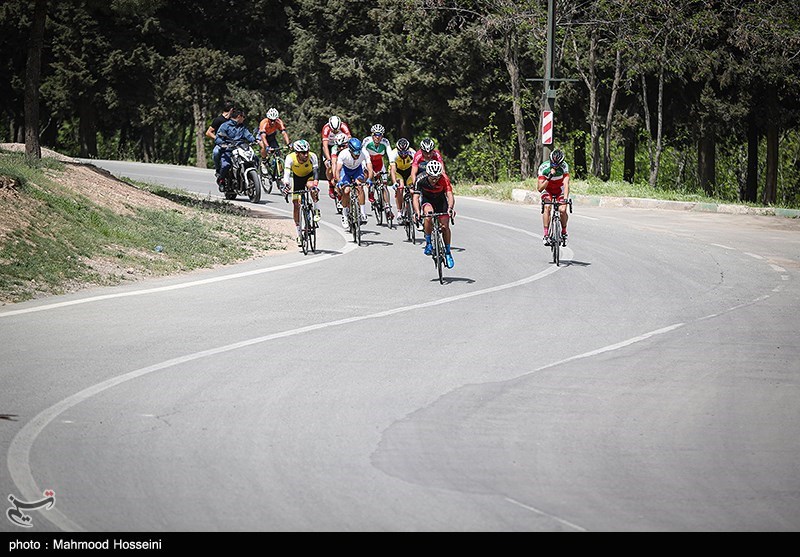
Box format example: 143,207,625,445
413,160,456,269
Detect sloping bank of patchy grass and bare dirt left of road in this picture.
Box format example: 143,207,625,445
0,152,285,303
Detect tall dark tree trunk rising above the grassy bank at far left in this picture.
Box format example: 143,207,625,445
25,0,47,159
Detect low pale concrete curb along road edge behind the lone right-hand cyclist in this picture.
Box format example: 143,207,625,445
511,189,800,219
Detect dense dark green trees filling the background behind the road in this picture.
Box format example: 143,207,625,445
0,0,800,205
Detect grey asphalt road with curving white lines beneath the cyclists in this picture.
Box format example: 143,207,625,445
0,161,800,532
